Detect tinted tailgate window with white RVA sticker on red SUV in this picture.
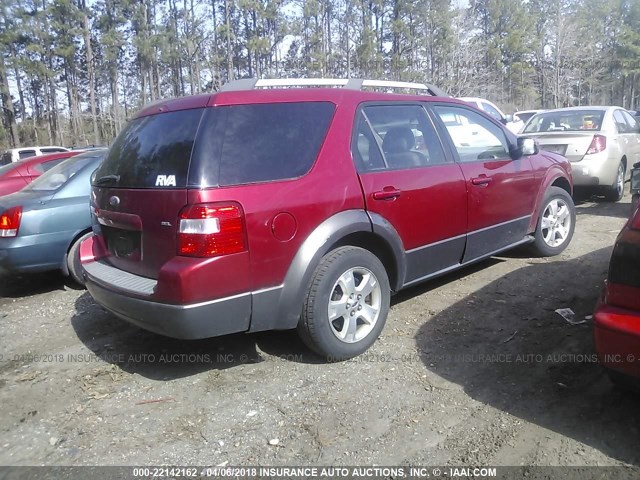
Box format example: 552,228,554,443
95,108,204,188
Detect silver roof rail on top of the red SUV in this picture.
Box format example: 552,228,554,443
220,78,449,97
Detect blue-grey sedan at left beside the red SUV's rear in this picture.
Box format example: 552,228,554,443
0,149,106,283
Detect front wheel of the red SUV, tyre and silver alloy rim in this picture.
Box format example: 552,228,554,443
533,187,576,257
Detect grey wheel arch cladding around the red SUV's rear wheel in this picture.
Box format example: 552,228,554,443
249,210,406,332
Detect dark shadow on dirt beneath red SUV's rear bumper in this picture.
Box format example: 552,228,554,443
71,292,324,380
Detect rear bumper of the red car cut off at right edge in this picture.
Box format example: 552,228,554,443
593,301,640,377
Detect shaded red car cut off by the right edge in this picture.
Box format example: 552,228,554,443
593,201,640,386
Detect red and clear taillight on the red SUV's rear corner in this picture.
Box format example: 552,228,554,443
178,203,246,257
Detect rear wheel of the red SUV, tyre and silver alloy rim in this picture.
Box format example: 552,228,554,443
298,246,391,361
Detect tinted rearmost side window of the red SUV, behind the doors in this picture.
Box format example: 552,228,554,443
189,102,335,187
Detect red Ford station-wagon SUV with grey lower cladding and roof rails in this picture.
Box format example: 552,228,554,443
80,79,575,360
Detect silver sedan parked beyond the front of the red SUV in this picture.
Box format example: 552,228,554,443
521,107,640,202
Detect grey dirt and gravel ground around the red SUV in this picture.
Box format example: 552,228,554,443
0,193,640,466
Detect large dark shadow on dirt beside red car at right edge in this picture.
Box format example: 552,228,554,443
416,248,640,465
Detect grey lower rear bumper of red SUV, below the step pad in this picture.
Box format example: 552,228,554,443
84,266,251,340
